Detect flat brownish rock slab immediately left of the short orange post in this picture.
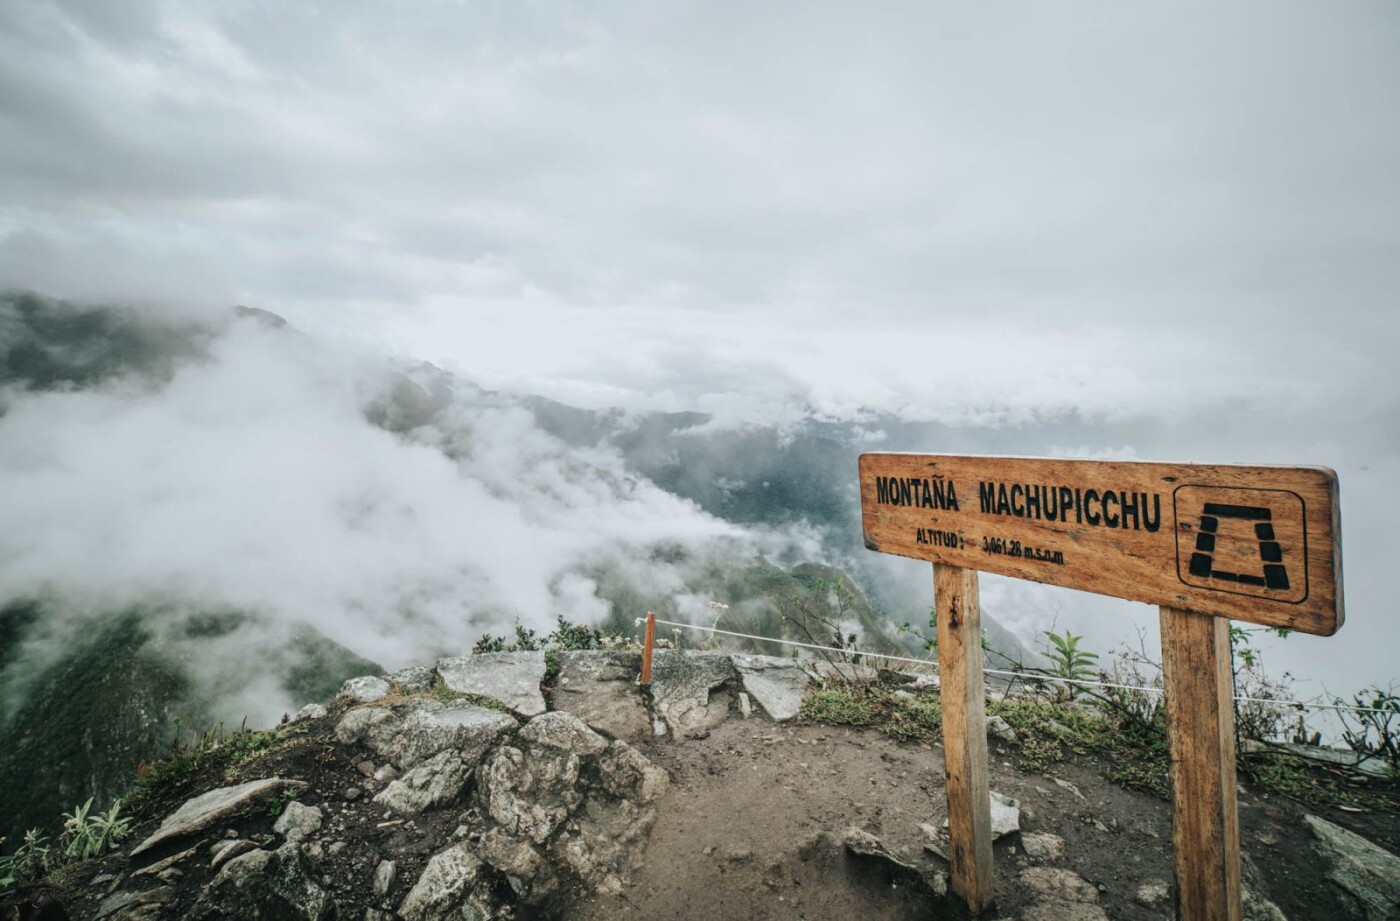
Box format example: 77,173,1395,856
550,649,651,740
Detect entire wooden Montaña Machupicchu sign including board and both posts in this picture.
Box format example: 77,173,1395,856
860,454,1343,921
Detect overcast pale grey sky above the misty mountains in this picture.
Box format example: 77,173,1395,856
0,0,1400,702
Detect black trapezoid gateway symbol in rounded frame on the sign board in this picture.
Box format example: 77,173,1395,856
1172,486,1308,603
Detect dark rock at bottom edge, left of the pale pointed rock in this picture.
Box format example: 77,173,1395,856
189,844,336,921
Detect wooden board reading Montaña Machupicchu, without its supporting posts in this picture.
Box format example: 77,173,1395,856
860,454,1343,635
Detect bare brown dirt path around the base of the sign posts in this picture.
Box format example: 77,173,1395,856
563,718,1394,921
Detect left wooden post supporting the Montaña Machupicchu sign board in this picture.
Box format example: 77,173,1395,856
934,563,993,915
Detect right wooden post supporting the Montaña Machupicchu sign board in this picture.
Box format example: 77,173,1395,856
1162,607,1240,921
